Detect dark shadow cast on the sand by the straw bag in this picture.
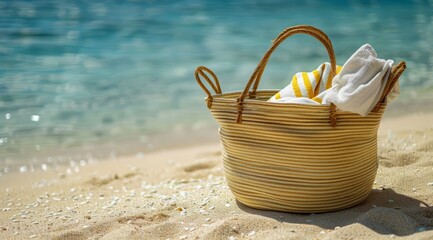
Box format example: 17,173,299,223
237,189,433,236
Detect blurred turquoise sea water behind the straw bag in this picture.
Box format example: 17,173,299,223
0,0,433,174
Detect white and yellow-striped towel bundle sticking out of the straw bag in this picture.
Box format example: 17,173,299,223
268,44,398,116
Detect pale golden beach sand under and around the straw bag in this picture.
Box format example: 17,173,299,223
0,113,433,239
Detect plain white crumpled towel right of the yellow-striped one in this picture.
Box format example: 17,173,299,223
322,44,394,116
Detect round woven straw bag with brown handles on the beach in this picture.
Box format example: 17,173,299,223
195,26,406,213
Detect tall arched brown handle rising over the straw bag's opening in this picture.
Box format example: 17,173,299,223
236,25,337,124
